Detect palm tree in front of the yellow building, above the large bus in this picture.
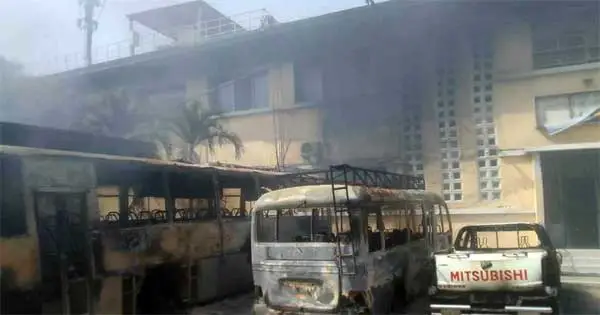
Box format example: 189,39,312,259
158,100,244,163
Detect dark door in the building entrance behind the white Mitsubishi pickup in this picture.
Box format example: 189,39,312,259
562,176,600,249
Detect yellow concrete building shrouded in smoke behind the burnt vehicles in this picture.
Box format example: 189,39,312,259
38,1,600,273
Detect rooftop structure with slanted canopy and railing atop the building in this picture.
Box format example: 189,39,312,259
31,0,277,75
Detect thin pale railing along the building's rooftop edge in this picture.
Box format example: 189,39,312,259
27,10,277,76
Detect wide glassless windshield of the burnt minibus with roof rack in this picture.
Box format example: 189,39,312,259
254,208,359,243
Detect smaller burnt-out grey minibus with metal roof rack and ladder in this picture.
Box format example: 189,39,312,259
251,165,452,314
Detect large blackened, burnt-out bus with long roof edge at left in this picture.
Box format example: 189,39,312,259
0,145,277,314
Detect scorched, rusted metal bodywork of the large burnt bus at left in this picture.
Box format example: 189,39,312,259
0,146,279,314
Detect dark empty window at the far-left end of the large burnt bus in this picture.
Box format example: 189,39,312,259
0,157,27,237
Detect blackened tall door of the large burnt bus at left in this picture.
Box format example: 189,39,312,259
34,192,92,314
